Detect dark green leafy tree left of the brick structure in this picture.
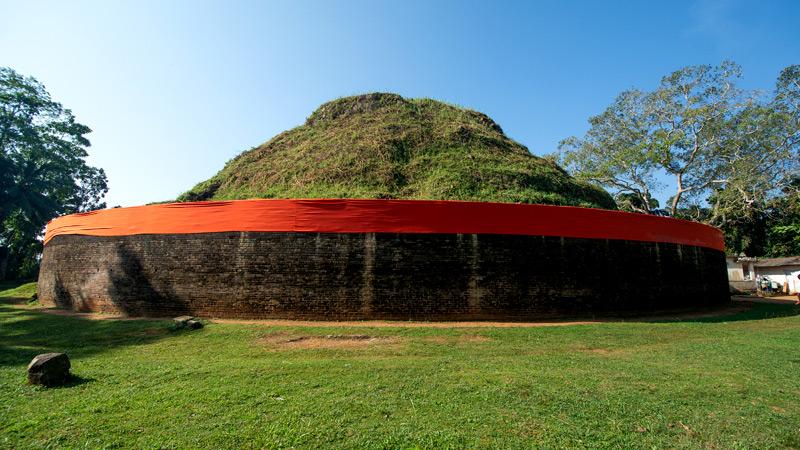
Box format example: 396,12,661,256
0,68,108,277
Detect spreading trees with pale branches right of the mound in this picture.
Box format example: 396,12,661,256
554,62,800,256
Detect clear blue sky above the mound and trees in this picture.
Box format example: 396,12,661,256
0,0,800,206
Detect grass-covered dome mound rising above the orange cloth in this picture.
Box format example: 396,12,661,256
178,93,615,209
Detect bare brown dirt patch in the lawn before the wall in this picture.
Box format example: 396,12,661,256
258,332,401,349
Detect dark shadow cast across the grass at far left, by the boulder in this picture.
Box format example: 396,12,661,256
0,299,176,370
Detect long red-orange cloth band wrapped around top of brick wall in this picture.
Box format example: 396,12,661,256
45,199,725,251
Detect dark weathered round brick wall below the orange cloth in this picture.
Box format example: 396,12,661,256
39,232,729,320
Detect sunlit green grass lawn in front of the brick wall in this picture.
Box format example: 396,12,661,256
0,284,800,448
